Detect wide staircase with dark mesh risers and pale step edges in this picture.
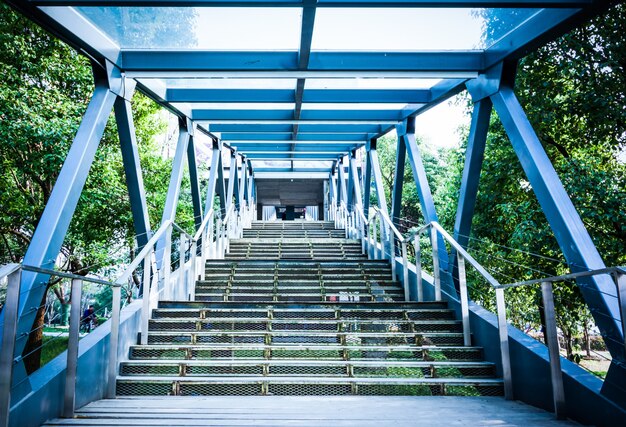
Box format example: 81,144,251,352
117,222,502,396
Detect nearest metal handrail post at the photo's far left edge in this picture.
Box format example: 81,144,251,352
0,268,22,427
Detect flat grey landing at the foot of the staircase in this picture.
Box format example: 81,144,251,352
46,396,577,427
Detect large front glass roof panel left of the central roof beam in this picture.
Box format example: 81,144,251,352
76,7,302,50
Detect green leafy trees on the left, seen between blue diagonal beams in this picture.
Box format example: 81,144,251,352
0,4,192,371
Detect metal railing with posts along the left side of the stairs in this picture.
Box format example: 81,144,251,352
0,201,256,427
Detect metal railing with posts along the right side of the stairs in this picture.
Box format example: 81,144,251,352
329,200,626,419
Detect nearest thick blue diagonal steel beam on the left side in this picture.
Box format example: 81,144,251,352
5,72,117,391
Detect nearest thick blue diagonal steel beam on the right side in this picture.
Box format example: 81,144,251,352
491,86,626,384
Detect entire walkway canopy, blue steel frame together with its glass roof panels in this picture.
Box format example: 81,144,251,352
3,0,626,426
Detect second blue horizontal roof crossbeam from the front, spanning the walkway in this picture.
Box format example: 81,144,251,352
165,88,432,103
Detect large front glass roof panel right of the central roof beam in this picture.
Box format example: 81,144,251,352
311,8,541,51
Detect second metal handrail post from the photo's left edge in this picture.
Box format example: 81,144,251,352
62,279,83,418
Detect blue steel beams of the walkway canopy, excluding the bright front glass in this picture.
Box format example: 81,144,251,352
0,0,626,422
